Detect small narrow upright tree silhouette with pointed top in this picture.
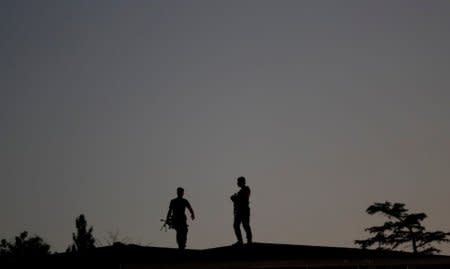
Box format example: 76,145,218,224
67,214,95,252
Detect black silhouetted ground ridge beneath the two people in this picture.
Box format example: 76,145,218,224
0,243,450,269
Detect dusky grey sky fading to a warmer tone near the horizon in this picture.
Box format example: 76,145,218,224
0,0,450,254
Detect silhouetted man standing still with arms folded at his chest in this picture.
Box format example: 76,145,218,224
231,177,252,245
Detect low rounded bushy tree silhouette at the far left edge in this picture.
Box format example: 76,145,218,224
0,231,50,258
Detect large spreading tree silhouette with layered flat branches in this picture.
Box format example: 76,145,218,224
355,202,450,254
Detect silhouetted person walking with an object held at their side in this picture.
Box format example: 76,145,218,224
166,187,195,249
